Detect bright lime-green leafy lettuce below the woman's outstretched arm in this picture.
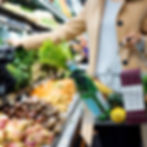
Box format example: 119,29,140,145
39,41,72,69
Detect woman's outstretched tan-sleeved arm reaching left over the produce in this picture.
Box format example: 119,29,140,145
16,9,86,49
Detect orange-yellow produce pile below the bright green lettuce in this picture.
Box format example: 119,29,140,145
31,78,76,112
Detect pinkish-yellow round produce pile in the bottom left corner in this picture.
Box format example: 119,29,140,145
0,115,54,147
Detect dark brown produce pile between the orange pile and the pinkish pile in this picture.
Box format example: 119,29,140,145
0,98,65,136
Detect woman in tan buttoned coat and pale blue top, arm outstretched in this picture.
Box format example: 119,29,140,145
11,0,147,147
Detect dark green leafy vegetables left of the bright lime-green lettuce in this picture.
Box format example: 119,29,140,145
7,48,37,90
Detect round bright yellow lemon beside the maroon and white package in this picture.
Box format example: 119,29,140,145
110,107,126,123
